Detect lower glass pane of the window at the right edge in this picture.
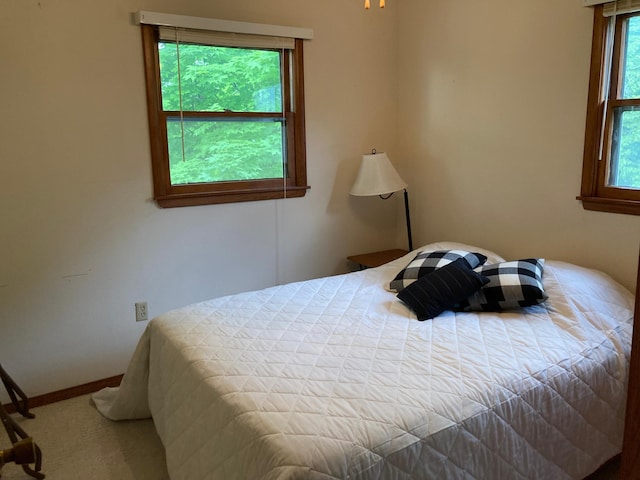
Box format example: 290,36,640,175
609,107,640,189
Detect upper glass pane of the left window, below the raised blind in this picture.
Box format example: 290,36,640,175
158,42,282,112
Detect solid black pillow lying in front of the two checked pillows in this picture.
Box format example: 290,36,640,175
397,258,489,320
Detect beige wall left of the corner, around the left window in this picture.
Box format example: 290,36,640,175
0,0,400,399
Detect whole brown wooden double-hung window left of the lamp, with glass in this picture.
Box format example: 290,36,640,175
141,25,308,207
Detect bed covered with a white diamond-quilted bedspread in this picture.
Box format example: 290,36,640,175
93,242,634,480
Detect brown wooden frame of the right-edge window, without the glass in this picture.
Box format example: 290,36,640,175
577,5,640,215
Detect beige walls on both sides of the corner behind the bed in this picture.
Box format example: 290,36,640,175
0,0,640,400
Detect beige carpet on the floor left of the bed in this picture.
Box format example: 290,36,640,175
0,395,169,480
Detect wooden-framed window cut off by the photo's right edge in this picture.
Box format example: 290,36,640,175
578,2,640,215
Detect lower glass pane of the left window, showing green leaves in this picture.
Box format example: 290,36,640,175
167,117,284,185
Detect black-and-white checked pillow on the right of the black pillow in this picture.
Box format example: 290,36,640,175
460,258,548,312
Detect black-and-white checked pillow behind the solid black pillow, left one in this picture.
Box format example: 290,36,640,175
389,250,487,292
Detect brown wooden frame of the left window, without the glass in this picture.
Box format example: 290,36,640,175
141,25,309,207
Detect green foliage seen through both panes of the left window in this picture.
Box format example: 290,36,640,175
158,42,285,185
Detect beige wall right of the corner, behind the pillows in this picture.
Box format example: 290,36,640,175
396,0,640,288
